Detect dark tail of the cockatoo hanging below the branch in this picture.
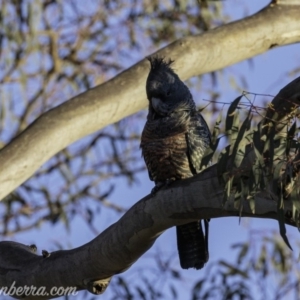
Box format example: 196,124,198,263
176,220,209,269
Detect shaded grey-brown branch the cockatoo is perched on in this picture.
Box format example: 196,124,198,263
0,166,294,299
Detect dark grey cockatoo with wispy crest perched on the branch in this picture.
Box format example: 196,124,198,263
141,57,210,269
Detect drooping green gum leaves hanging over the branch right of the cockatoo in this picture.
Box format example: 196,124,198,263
210,95,300,249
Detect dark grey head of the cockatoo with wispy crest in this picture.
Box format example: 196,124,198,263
146,56,195,117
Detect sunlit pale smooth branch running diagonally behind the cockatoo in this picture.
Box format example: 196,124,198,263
0,4,300,199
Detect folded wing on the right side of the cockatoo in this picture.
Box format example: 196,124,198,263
186,112,211,174
